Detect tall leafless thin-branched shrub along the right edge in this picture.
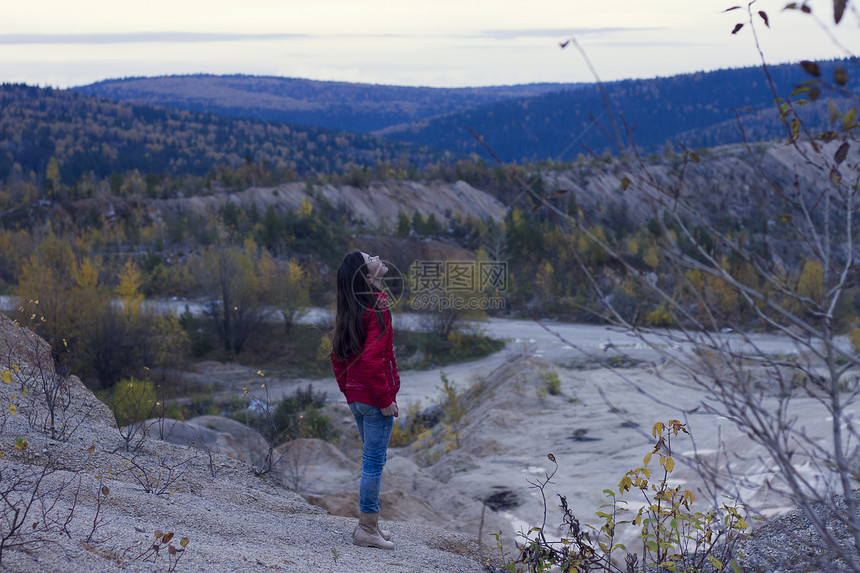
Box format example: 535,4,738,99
516,7,860,571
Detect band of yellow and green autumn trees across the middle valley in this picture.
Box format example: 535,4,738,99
0,135,860,392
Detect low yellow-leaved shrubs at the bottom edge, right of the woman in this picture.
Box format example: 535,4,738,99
496,420,749,573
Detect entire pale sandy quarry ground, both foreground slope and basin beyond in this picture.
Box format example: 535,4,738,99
0,308,857,572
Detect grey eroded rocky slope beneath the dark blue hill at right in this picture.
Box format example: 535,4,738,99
543,141,860,230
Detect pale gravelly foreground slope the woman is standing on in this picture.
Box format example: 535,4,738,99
0,315,490,573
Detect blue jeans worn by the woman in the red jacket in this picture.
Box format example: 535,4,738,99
349,402,394,513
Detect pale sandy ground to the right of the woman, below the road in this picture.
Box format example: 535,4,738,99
256,316,860,543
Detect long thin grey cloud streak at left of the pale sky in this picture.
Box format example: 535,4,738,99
0,32,307,45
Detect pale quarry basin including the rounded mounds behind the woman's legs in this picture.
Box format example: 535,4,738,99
207,316,858,556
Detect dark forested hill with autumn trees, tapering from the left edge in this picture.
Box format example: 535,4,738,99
0,84,441,192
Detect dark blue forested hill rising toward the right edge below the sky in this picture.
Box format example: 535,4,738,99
379,60,860,162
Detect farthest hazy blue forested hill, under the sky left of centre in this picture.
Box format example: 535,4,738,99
72,75,585,133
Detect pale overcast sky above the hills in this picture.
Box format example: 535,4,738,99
0,0,860,88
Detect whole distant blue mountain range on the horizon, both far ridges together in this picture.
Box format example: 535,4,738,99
75,60,860,163
